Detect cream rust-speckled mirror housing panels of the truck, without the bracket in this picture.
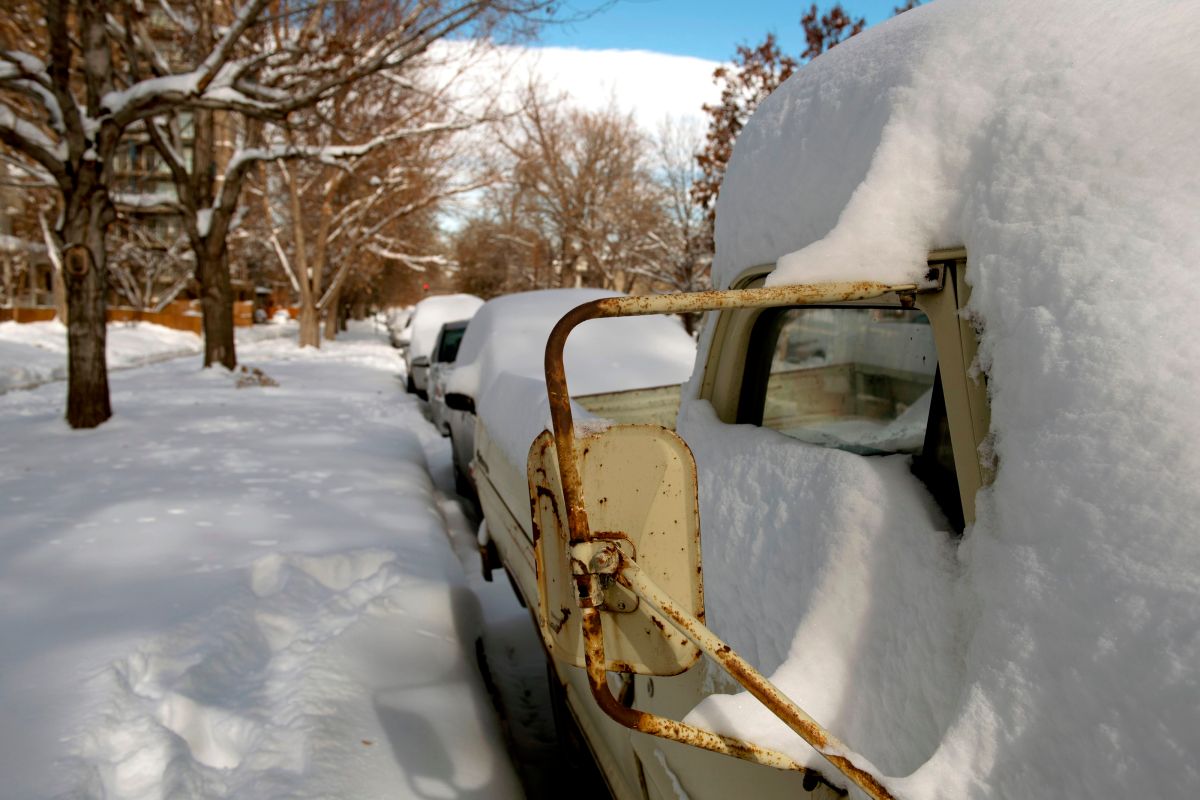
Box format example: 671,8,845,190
528,425,704,675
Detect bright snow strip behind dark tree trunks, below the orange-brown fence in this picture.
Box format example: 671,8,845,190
0,320,296,393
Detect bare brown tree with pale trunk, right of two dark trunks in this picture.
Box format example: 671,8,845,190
260,63,479,347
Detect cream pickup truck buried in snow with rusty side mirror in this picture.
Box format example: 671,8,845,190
472,0,1200,800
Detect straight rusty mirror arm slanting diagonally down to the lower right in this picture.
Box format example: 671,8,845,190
619,558,893,800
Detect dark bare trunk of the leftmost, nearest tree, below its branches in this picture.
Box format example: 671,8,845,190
62,198,113,428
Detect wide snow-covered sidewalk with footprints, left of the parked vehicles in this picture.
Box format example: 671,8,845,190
0,326,521,799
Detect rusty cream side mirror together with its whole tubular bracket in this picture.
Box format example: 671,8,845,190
528,280,943,800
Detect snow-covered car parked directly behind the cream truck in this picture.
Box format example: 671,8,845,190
445,289,696,501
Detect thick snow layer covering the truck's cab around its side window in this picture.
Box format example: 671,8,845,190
684,0,1200,799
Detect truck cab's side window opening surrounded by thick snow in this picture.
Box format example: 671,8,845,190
738,306,964,533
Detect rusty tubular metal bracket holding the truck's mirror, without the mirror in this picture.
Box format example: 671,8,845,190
545,281,912,800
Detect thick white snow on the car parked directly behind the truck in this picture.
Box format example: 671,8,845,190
446,289,696,464
